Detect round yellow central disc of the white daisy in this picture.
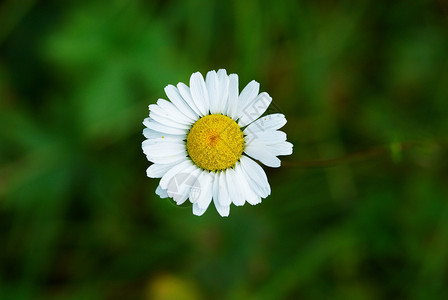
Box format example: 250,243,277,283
187,115,244,171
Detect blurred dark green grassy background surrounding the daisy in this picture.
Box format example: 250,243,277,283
0,0,448,300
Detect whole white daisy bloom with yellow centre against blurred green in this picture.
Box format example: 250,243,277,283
142,69,293,217
